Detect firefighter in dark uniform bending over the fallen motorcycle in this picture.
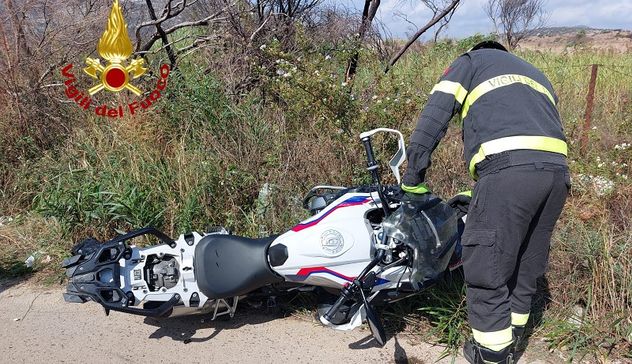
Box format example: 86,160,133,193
402,41,570,363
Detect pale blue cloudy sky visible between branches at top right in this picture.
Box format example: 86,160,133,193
330,0,632,38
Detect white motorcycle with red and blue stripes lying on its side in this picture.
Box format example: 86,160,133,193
62,128,465,345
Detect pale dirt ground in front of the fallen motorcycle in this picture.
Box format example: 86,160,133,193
0,283,560,364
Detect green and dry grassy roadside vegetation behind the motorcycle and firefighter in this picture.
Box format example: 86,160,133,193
0,3,632,360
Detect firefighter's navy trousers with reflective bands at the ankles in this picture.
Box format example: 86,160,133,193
462,154,570,350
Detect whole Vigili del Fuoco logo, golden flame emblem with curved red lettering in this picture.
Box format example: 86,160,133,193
62,0,170,118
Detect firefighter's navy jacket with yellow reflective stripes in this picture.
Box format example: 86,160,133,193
403,49,567,186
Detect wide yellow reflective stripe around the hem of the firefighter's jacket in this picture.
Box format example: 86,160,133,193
469,136,568,179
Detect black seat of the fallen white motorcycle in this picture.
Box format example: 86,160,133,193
194,235,283,299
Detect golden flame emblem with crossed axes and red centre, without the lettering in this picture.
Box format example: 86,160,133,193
83,0,147,96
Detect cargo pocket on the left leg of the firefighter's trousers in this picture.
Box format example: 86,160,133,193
462,229,498,288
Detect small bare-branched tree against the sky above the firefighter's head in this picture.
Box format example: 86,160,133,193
485,0,547,49
